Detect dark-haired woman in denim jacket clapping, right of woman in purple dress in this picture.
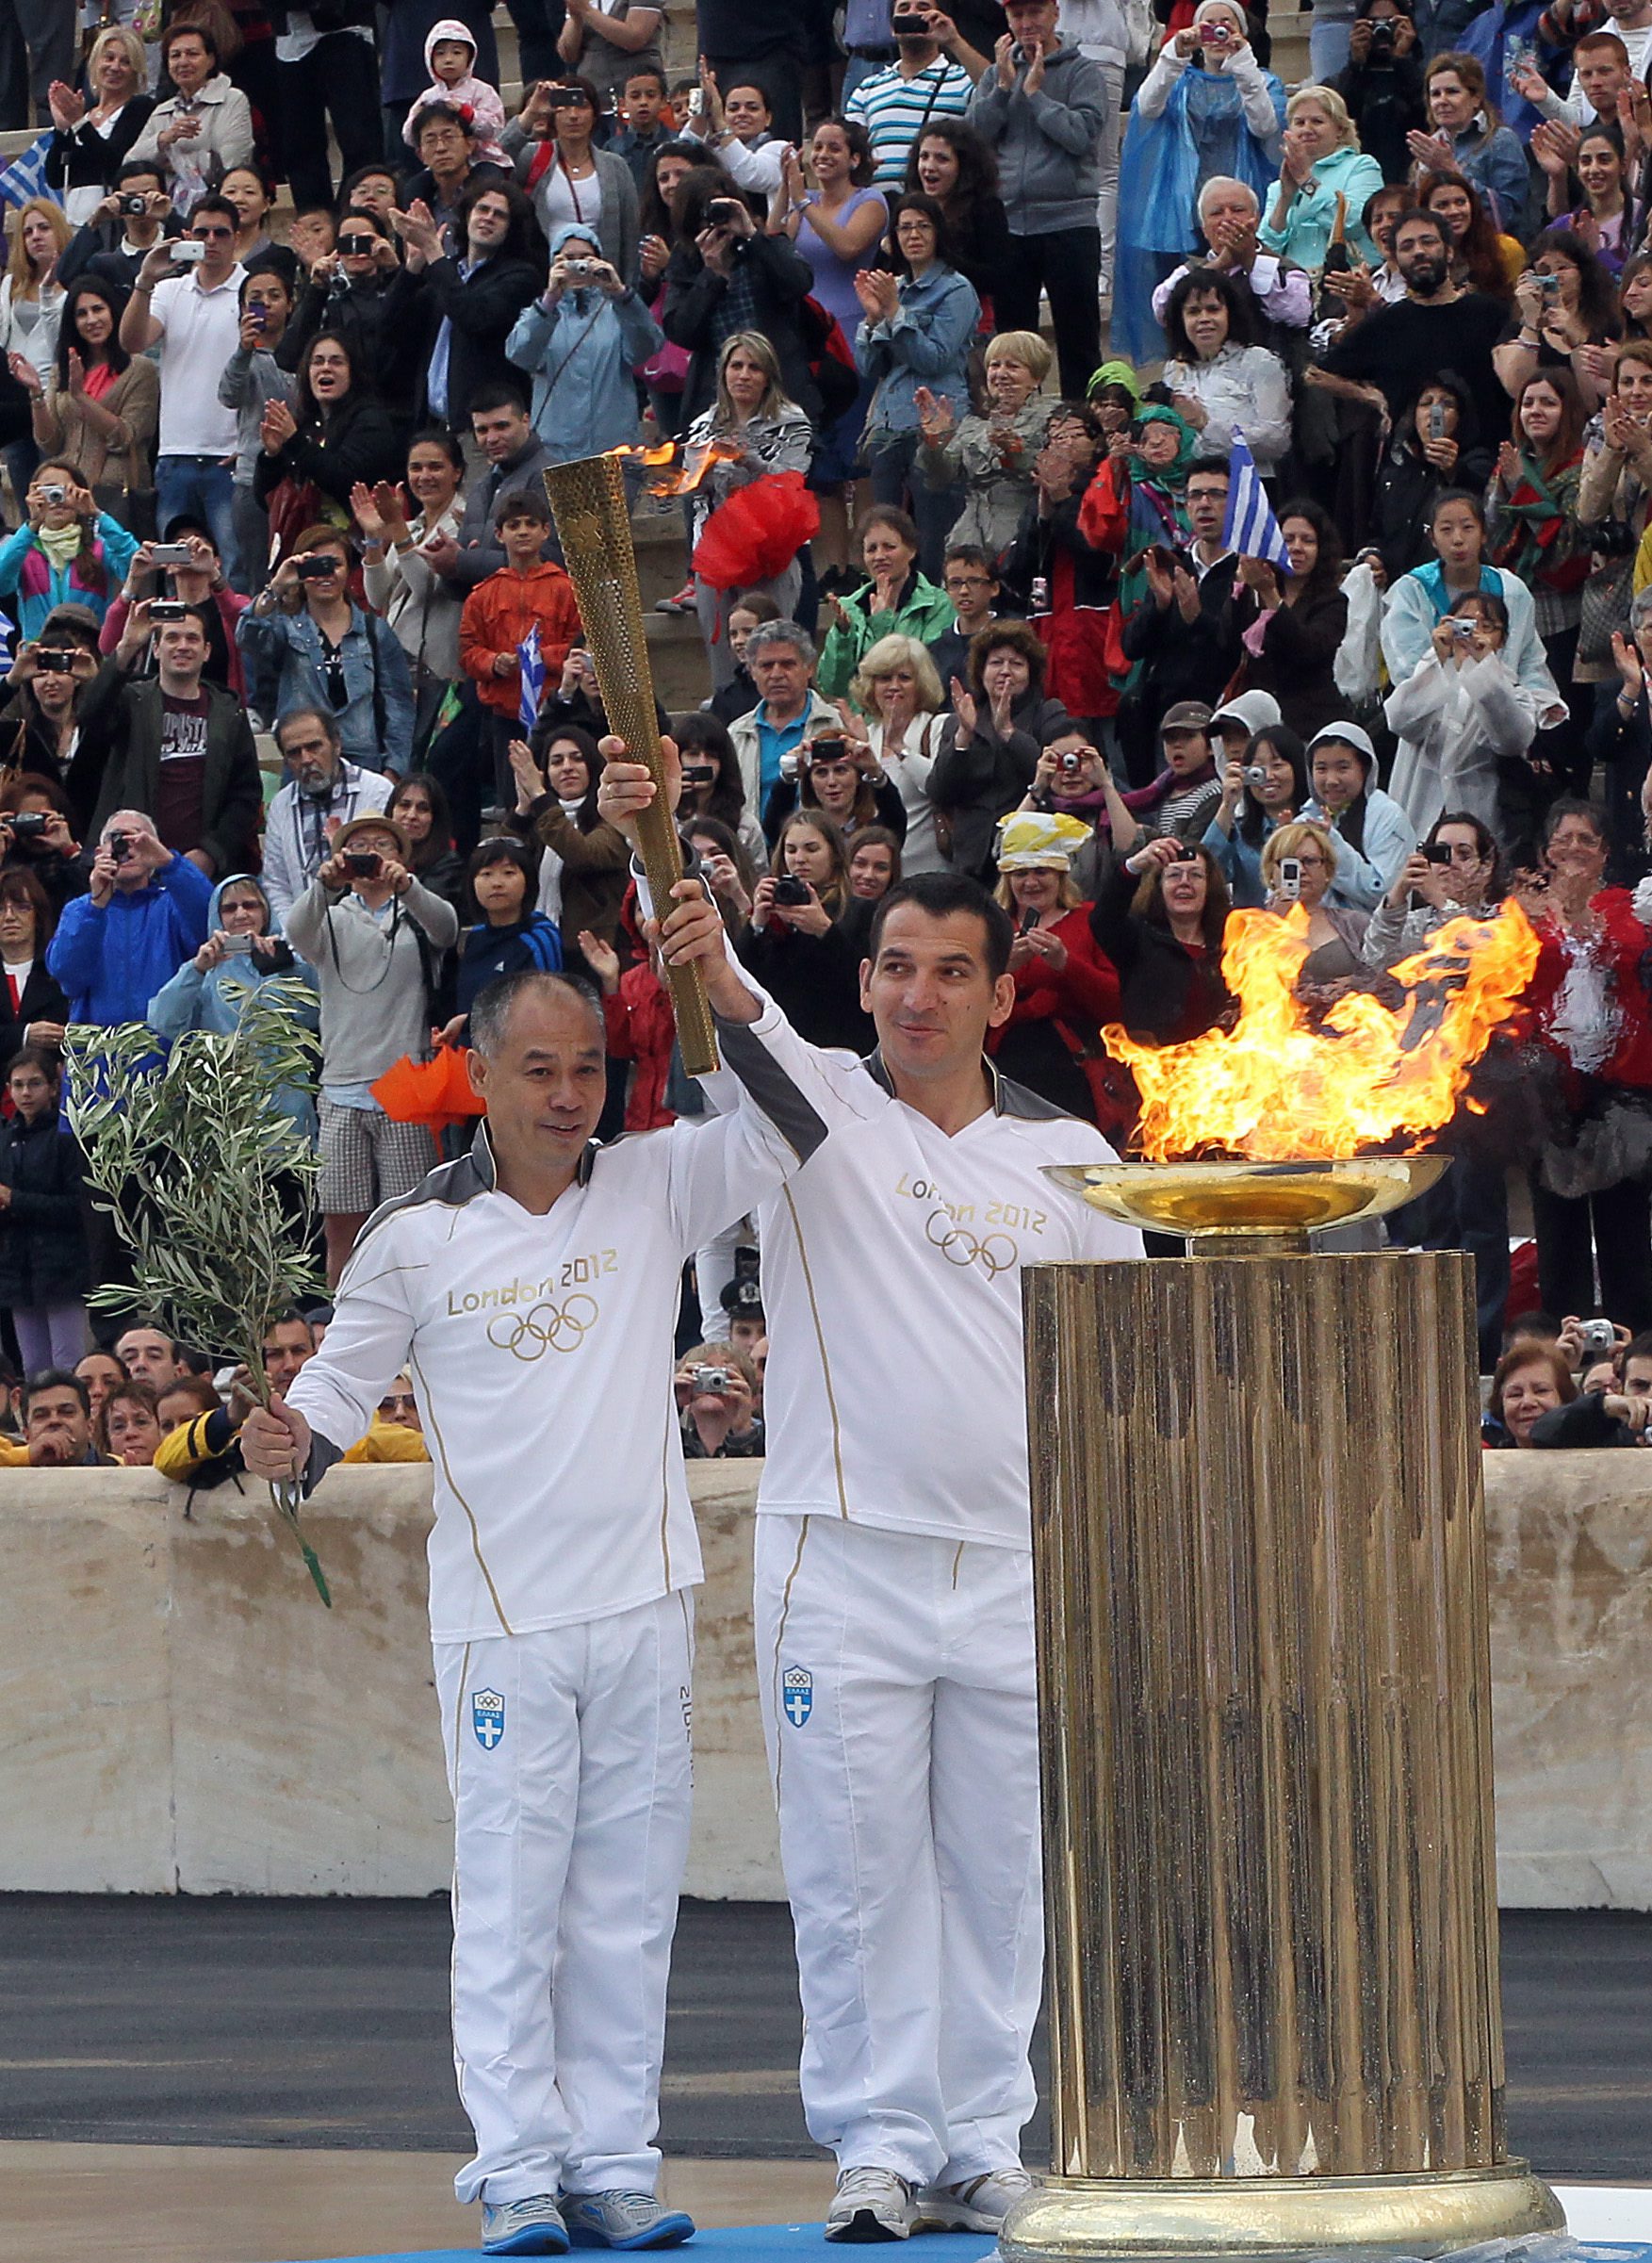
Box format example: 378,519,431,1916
856,192,980,582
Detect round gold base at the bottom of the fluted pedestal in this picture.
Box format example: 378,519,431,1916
998,2161,1566,2263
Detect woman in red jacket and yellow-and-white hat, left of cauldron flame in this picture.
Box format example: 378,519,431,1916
987,811,1129,1132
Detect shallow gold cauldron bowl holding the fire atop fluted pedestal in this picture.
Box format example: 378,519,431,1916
1043,1155,1450,1258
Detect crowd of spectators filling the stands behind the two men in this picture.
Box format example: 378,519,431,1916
0,0,1652,1448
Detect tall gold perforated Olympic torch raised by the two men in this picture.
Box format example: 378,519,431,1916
546,455,717,1077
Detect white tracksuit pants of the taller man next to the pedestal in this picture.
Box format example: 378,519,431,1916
756,1517,1043,2184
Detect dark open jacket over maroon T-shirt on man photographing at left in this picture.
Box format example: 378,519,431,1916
70,659,265,878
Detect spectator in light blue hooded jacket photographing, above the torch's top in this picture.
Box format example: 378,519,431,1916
505,221,665,464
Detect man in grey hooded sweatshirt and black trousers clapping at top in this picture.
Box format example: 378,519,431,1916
969,0,1109,401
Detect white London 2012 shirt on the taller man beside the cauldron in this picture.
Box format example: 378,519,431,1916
701,1009,1140,1548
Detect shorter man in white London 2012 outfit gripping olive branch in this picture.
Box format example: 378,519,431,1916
242,887,824,2256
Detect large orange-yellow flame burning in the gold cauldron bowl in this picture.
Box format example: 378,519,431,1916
1102,903,1539,1163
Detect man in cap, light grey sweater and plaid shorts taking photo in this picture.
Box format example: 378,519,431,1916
286,812,459,1283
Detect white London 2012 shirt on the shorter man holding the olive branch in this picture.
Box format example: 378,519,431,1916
287,1011,824,1643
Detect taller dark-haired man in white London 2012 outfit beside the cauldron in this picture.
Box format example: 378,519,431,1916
597,740,1140,2240
